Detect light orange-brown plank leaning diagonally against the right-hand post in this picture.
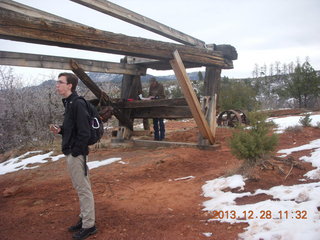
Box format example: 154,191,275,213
170,50,215,144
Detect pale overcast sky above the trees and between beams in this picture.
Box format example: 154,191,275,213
0,0,320,82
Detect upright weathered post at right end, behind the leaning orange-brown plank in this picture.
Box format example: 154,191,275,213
198,67,221,146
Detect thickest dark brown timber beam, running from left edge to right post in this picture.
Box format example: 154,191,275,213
0,2,233,69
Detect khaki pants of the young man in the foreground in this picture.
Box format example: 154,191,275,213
67,154,95,228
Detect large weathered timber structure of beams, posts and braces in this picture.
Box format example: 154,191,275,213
0,0,237,144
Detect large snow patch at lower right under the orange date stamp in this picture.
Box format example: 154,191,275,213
202,134,320,240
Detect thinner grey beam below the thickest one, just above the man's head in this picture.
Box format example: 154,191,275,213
0,51,146,75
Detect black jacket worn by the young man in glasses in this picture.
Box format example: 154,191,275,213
60,92,90,157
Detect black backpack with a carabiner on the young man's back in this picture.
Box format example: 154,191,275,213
74,96,104,145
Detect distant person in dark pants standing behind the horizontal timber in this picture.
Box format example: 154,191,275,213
149,77,165,141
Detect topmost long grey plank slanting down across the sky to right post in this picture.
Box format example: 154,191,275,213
71,0,205,48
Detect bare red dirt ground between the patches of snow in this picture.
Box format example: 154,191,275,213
0,114,320,240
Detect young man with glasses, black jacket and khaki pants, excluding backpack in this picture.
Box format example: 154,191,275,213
50,73,97,239
